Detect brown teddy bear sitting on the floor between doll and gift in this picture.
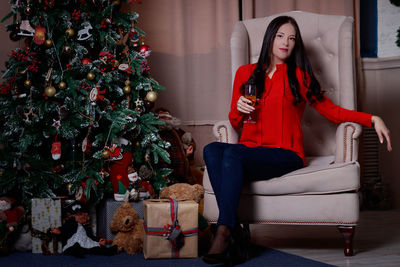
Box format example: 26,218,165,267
110,202,144,254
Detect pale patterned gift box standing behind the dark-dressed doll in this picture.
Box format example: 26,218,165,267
31,198,62,254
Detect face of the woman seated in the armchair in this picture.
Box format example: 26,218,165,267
272,23,296,65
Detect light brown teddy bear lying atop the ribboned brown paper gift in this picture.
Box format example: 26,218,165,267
160,183,204,203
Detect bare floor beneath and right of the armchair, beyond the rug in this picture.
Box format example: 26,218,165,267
250,210,400,267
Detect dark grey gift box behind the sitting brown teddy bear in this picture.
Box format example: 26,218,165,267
97,199,143,240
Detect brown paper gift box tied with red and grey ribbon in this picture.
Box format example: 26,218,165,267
143,199,198,259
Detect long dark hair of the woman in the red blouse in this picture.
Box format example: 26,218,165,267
248,16,323,105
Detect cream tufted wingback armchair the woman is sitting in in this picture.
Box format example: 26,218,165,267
203,11,361,256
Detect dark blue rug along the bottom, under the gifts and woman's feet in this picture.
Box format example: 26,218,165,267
0,247,333,267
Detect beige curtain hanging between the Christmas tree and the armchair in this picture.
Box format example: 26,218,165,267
130,0,239,125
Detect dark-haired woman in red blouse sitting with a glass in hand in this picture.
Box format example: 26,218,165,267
203,16,392,263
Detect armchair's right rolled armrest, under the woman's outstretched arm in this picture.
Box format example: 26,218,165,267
335,122,362,163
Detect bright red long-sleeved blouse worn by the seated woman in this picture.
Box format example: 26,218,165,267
229,64,372,162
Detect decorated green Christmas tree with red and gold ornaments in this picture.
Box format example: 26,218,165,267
0,0,170,206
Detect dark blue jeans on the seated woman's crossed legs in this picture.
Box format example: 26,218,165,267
203,142,303,229
